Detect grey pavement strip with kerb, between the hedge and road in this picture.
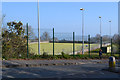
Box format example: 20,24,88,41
2,59,108,68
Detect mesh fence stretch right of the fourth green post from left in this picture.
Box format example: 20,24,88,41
90,35,119,58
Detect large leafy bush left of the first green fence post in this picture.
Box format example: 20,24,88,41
2,22,27,58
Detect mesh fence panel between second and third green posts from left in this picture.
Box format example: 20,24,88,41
54,32,73,55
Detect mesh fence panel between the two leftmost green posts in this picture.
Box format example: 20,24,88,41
26,28,53,55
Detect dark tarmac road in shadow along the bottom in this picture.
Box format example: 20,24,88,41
2,63,120,78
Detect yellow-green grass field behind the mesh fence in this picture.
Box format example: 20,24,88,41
29,43,97,55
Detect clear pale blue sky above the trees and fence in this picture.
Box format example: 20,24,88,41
2,2,118,36
